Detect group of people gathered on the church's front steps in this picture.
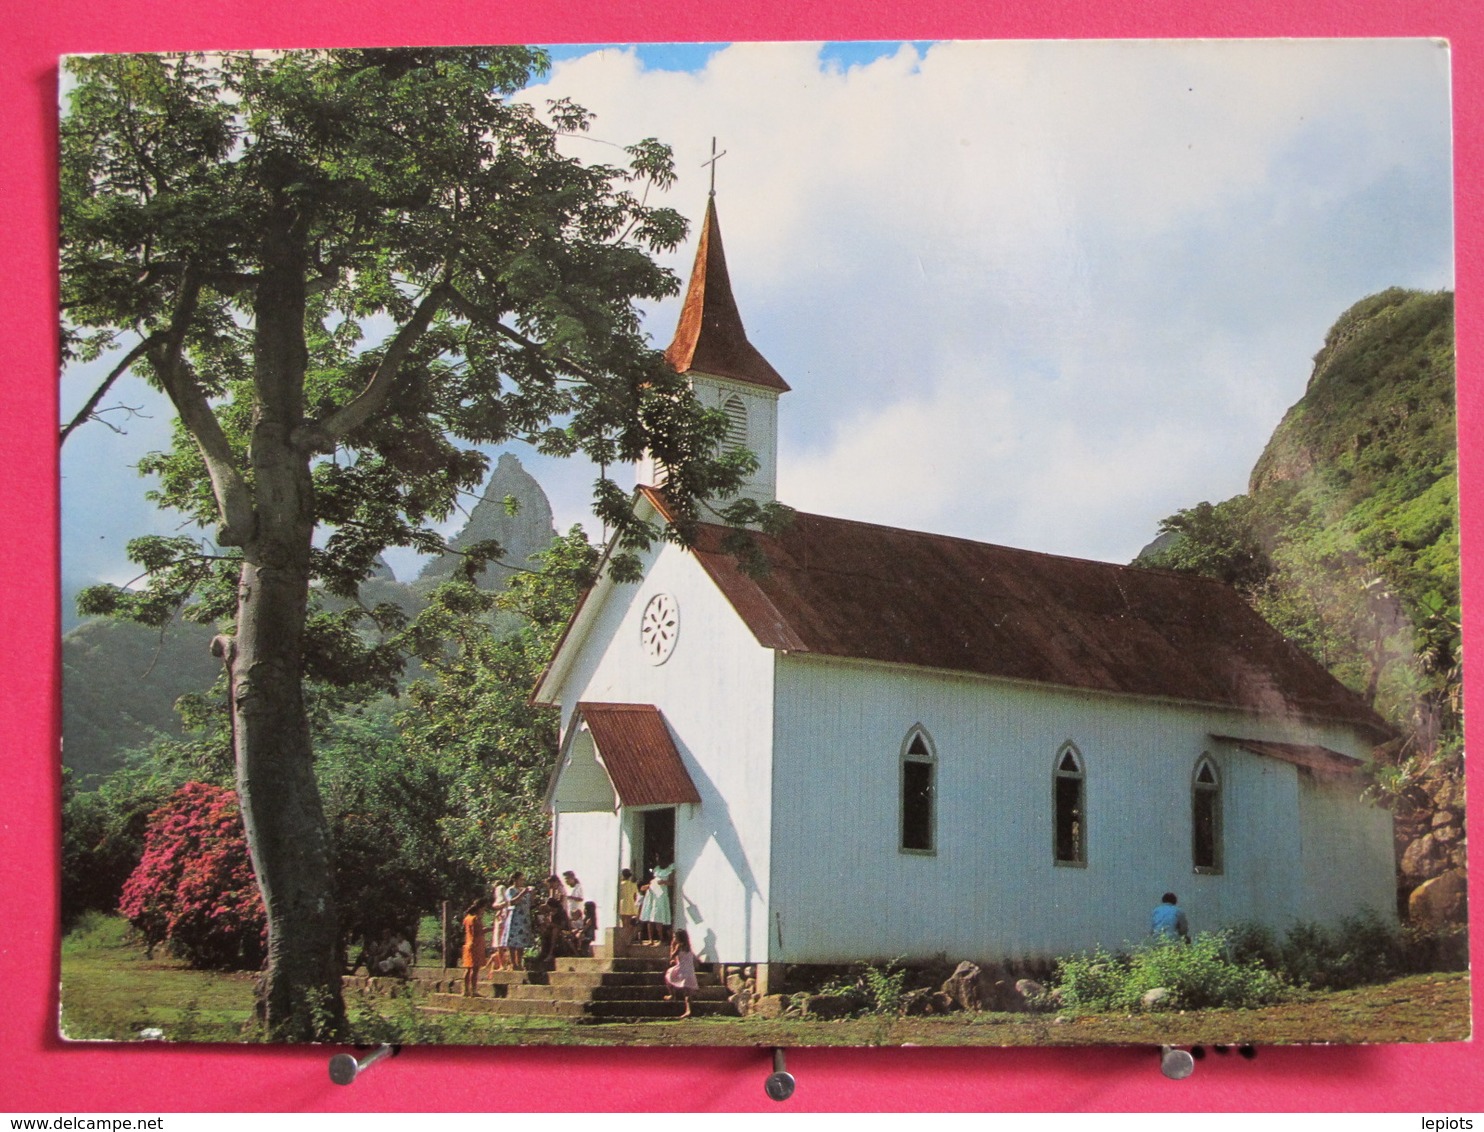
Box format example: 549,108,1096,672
462,865,699,1018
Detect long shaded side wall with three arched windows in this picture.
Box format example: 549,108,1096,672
772,656,1392,963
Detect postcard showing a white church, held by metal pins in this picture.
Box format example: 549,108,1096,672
59,40,1469,1046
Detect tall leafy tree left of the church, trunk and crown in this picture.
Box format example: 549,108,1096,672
61,47,758,1040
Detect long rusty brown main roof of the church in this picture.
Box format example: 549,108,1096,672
641,488,1391,740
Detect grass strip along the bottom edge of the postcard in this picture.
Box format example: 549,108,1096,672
62,918,1469,1046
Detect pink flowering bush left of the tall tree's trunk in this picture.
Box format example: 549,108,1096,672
119,782,267,969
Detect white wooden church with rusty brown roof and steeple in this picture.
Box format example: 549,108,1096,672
534,189,1396,991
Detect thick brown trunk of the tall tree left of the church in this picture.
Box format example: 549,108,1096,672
232,198,346,1041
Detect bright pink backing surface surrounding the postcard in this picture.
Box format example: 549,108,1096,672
0,0,1484,1113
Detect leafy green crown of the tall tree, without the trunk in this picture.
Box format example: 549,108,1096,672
61,47,746,623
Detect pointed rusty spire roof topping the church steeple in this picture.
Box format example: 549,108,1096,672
665,197,788,393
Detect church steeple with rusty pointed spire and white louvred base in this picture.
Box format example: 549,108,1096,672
638,193,788,503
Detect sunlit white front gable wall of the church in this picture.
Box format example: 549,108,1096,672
557,544,773,963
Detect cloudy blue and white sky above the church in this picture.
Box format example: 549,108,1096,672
62,40,1453,593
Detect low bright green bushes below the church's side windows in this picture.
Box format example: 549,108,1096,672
1052,932,1293,1012
